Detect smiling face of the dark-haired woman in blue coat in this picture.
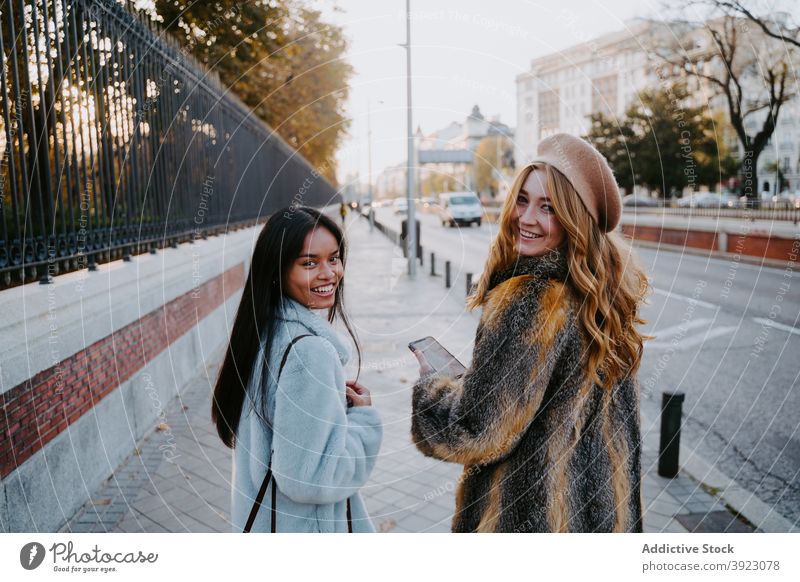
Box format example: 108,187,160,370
286,226,344,309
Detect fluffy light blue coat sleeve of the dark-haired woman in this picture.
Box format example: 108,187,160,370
272,336,382,504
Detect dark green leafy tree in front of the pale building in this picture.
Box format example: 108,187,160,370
587,85,737,197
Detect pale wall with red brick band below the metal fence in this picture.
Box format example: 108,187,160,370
0,227,260,532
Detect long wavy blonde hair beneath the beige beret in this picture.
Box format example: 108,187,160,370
467,163,650,388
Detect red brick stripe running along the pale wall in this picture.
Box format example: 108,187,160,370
0,263,245,478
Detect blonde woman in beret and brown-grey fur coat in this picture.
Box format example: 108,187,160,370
412,134,648,532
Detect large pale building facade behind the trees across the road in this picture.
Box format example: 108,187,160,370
515,19,800,197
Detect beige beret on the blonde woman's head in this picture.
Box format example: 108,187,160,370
532,133,622,232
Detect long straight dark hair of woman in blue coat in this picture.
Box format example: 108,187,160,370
211,206,361,448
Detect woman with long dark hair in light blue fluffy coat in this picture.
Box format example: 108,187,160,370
211,207,382,532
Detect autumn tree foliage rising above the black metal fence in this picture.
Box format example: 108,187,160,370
150,0,353,183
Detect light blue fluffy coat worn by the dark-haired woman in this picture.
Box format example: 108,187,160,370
231,298,383,533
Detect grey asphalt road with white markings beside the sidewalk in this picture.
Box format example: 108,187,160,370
376,208,800,522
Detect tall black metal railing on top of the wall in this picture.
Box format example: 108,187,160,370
0,0,337,288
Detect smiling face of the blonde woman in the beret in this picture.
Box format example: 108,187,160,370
512,170,566,257
